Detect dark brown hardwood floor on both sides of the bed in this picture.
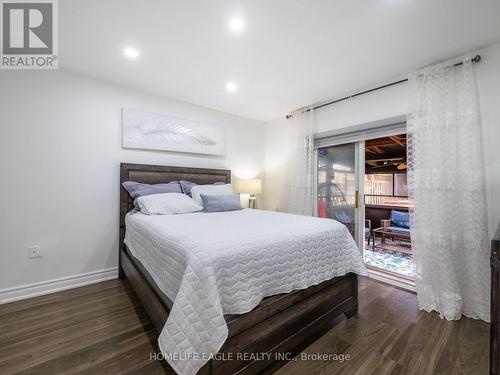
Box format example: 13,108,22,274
0,278,489,375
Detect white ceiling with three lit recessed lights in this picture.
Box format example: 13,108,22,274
59,0,500,120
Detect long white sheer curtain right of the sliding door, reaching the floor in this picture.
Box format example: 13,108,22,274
408,56,490,321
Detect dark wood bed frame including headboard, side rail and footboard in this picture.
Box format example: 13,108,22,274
119,163,358,374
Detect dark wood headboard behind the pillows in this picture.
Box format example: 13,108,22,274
119,163,231,258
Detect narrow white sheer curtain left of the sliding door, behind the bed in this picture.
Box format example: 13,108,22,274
288,108,314,216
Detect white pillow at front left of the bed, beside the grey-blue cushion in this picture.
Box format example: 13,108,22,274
136,193,203,215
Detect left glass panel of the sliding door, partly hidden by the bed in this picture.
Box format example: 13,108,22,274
317,142,364,249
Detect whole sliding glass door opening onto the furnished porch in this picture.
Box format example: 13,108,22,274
314,122,414,290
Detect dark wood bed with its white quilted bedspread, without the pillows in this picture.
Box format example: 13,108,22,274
119,164,365,374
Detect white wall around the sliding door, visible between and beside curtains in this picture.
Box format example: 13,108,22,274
264,44,500,241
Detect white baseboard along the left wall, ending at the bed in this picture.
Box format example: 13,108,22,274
0,267,118,304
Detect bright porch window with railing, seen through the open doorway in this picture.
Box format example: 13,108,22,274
365,173,410,207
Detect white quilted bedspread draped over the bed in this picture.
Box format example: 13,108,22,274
125,209,366,375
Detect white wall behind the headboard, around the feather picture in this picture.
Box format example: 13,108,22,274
0,71,265,300
